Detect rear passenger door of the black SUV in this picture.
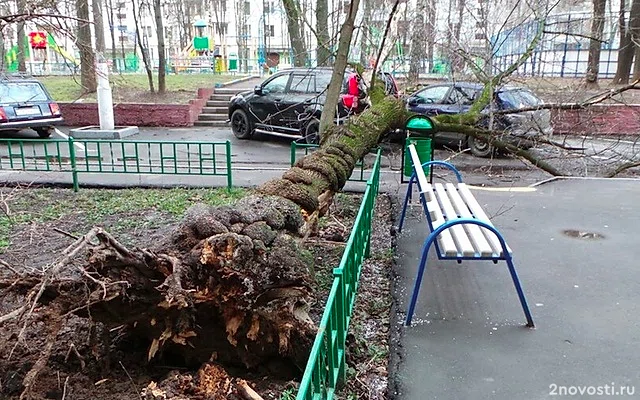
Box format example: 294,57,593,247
282,71,318,132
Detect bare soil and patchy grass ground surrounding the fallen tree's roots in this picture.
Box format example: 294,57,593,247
0,188,393,400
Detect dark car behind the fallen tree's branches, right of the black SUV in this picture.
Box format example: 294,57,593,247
407,82,553,157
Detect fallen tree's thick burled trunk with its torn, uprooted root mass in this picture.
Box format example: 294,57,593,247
0,99,406,399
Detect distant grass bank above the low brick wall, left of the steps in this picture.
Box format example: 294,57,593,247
39,74,244,103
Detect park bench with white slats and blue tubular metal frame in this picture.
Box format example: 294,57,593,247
398,145,534,327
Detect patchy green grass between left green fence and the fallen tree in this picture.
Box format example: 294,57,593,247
0,188,247,254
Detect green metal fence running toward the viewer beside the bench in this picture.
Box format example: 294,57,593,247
292,146,381,400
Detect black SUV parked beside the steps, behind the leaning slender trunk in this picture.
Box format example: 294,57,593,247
229,67,368,143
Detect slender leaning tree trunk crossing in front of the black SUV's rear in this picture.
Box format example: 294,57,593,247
319,0,360,134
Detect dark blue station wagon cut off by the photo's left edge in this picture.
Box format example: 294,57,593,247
0,76,63,138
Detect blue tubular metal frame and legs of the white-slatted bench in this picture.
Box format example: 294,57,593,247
398,161,534,328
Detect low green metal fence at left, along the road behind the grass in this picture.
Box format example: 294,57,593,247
0,138,233,191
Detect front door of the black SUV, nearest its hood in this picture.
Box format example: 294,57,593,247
249,72,291,129
